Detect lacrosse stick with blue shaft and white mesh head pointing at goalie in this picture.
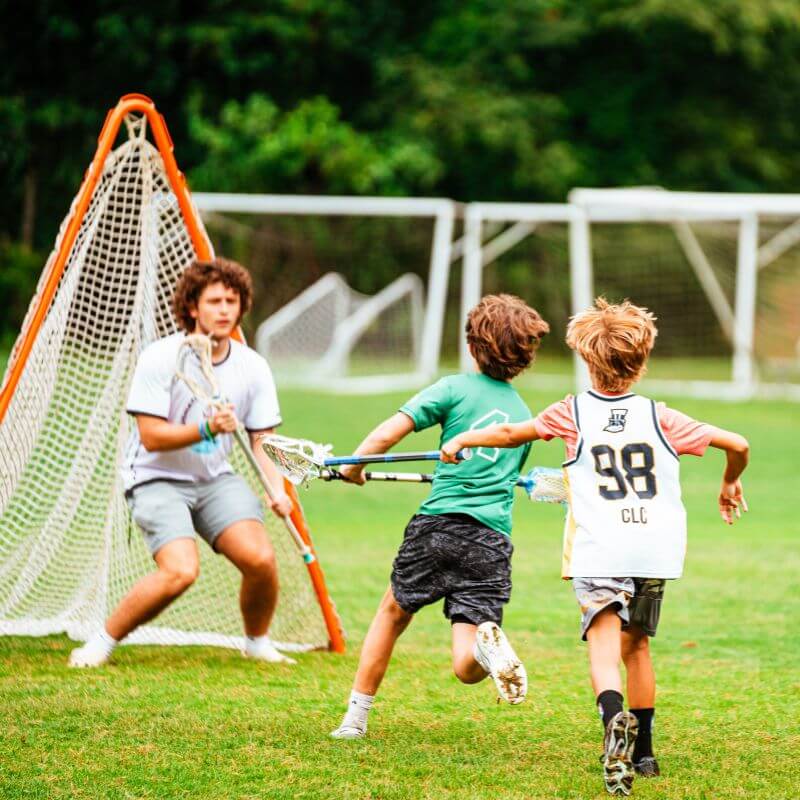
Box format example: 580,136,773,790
260,434,472,485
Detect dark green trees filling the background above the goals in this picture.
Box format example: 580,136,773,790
0,0,800,335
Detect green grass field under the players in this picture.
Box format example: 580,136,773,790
0,381,800,800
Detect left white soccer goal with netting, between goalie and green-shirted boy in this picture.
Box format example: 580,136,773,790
194,193,456,392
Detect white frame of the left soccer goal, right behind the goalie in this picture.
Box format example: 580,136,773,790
193,192,457,393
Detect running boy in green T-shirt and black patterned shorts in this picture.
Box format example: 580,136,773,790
331,295,549,739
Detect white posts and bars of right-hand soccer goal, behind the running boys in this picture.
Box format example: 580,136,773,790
461,188,800,400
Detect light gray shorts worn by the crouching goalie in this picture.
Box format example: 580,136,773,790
128,474,264,555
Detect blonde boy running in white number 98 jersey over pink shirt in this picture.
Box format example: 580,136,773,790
442,298,749,794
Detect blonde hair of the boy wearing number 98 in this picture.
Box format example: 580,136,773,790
567,297,658,392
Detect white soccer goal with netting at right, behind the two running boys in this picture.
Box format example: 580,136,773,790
462,189,800,399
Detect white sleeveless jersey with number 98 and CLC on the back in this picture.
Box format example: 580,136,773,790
562,391,686,578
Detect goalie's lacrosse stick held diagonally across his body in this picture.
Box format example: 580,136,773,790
175,333,315,564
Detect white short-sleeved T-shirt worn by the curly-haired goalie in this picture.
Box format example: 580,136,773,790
122,333,281,490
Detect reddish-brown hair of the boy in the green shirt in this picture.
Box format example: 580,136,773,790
466,294,550,381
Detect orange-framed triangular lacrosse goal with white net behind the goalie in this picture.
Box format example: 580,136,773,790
0,95,343,650
